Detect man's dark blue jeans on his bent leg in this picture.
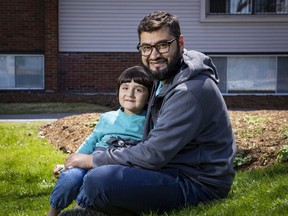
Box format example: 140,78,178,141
83,165,213,215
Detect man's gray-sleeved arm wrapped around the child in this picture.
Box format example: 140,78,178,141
93,90,203,169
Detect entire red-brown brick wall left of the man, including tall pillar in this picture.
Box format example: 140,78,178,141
0,0,144,93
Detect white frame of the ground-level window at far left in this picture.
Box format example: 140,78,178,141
0,53,45,91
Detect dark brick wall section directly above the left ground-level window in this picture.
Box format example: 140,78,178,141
0,0,44,53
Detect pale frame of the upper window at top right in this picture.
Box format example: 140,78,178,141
200,0,288,23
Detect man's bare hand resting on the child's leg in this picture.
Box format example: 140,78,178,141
64,153,93,169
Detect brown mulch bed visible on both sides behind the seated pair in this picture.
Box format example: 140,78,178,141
40,110,288,170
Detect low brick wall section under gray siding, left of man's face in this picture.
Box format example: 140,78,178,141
58,52,140,93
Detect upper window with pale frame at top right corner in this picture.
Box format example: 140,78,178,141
200,0,288,23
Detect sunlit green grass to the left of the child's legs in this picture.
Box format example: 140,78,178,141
0,123,66,216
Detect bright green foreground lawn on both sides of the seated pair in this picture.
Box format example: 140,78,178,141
0,123,288,216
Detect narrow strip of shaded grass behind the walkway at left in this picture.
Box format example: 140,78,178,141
0,103,111,114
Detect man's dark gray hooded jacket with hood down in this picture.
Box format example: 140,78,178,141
93,50,236,198
